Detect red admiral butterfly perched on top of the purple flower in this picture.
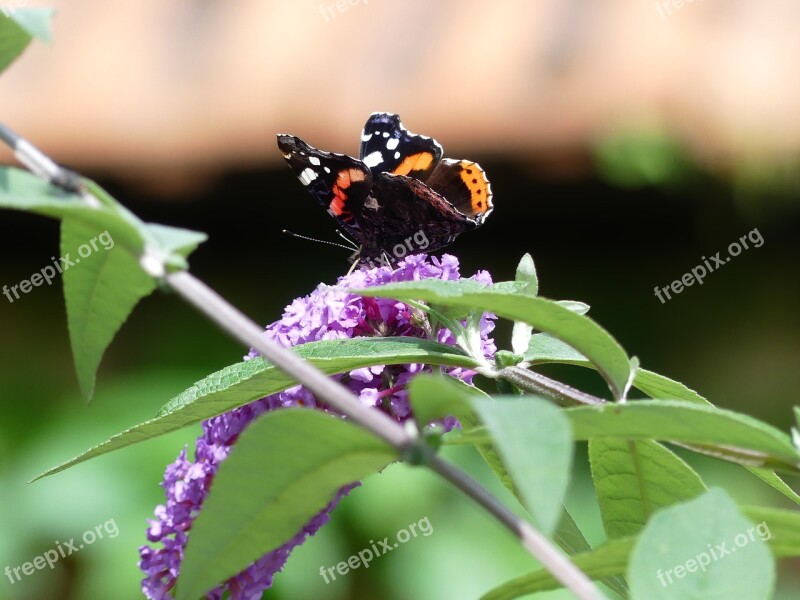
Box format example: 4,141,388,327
278,113,493,264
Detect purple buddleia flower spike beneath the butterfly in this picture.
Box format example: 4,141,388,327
139,254,495,600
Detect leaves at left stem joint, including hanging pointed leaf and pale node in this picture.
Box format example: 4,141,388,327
0,167,205,400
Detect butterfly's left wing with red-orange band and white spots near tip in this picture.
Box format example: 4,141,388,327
278,134,372,242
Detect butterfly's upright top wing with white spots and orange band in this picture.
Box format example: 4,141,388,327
359,113,442,181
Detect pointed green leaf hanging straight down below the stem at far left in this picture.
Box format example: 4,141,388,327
61,218,155,400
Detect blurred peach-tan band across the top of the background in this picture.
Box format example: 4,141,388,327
0,0,800,184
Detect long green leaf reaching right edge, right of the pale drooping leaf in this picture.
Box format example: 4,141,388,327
564,400,800,472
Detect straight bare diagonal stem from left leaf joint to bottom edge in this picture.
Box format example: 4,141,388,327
166,271,603,600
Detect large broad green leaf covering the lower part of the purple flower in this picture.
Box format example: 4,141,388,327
177,408,397,600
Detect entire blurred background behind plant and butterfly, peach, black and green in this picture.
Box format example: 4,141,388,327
0,0,800,600
